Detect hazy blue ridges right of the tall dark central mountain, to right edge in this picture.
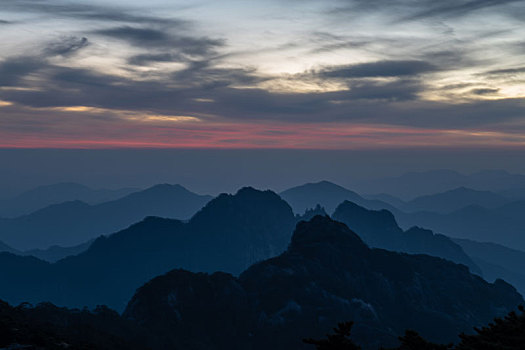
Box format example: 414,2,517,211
281,180,525,254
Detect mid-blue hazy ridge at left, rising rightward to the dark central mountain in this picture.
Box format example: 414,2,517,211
0,185,211,250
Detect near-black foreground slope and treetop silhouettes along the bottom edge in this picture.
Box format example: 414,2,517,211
0,301,525,350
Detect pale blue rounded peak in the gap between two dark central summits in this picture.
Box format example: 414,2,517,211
280,181,392,213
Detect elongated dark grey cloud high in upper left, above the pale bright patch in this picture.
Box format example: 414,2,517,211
94,26,224,56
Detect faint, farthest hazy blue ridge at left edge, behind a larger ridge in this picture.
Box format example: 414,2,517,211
0,182,140,218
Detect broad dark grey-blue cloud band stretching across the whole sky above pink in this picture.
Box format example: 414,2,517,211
0,58,525,133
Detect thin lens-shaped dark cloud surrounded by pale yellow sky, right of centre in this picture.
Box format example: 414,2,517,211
319,61,438,79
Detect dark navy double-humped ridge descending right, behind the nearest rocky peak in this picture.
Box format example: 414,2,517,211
332,201,481,274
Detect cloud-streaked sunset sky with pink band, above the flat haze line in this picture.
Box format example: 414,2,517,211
0,0,525,149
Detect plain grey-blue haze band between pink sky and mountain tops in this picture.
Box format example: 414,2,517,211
0,148,525,200
